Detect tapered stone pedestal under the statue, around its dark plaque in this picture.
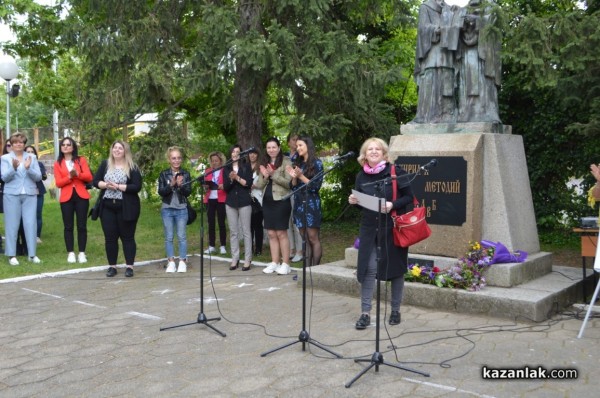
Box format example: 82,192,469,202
390,123,540,258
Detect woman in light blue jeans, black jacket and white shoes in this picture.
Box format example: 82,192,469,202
158,147,192,272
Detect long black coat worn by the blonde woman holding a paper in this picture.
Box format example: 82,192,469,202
354,163,413,283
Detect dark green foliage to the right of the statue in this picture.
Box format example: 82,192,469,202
500,1,600,228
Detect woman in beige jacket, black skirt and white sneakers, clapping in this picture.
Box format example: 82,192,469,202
256,137,292,275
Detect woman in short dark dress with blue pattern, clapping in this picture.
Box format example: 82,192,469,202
287,136,323,266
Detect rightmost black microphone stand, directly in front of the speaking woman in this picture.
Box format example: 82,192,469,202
345,163,429,388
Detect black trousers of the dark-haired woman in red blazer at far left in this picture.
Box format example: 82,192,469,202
60,188,90,253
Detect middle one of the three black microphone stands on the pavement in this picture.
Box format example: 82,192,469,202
260,163,342,358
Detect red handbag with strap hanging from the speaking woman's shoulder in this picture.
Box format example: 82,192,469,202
391,165,431,247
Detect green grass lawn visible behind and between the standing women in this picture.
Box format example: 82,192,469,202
0,195,358,279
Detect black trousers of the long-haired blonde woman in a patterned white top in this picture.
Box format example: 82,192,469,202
100,199,137,266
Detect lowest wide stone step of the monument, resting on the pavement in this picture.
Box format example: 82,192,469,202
298,260,582,322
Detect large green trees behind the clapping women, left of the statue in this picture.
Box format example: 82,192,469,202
5,0,419,208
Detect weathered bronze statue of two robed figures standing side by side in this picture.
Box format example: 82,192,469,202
411,0,502,123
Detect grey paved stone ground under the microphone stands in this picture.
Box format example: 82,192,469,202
0,257,600,398
